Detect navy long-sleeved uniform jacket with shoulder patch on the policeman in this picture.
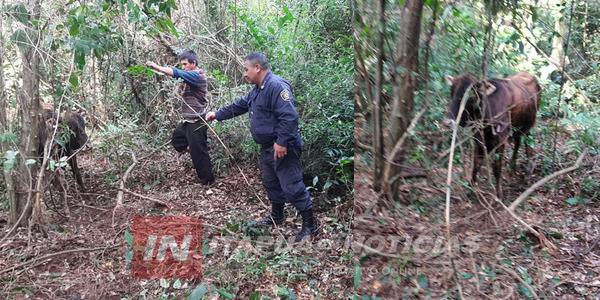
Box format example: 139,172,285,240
216,71,304,147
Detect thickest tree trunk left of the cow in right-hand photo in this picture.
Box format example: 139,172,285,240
383,0,425,201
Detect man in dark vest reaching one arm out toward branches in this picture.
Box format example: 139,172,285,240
146,50,215,185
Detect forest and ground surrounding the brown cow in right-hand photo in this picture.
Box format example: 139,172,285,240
355,0,600,299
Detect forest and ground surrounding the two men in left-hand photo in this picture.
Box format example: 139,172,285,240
0,0,354,299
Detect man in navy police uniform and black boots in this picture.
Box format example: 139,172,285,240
206,52,319,243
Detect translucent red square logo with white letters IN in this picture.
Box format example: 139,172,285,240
132,216,202,279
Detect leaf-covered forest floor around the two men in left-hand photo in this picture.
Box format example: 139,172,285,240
0,145,353,300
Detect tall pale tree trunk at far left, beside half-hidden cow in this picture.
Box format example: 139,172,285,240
9,0,40,226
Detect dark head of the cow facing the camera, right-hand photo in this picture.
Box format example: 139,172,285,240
444,74,496,126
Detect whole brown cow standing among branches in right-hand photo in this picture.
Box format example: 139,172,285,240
445,72,541,199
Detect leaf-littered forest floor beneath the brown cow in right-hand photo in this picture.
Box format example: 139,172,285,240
354,116,600,299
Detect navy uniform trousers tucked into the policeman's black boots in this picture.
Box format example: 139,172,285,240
260,147,312,211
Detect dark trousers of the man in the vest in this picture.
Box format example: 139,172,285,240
171,120,215,184
